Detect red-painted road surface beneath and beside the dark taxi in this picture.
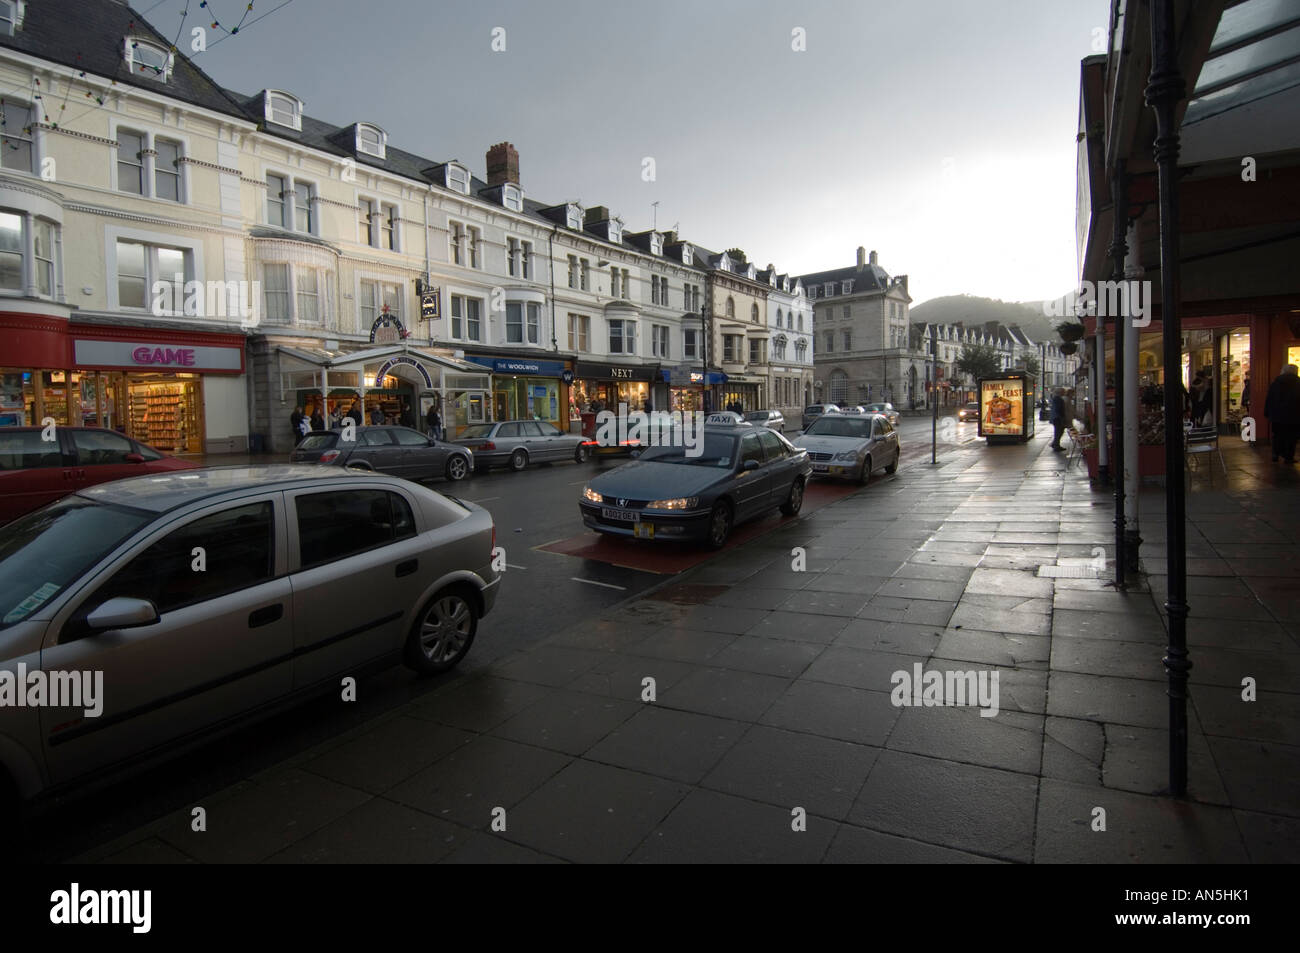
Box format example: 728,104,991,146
533,480,859,576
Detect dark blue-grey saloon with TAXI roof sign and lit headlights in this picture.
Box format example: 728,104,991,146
579,424,813,549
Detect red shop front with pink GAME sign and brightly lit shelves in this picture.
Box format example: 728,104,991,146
0,316,248,454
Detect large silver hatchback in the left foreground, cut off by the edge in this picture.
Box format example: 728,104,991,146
0,464,499,807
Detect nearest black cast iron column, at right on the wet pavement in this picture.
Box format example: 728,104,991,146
1145,0,1192,797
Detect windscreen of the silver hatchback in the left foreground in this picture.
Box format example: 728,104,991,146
0,497,153,629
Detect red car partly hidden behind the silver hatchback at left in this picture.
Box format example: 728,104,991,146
0,426,198,524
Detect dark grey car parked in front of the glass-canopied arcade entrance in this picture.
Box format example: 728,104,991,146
289,426,475,482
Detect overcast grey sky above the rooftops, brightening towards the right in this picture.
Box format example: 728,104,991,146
165,0,1108,303
